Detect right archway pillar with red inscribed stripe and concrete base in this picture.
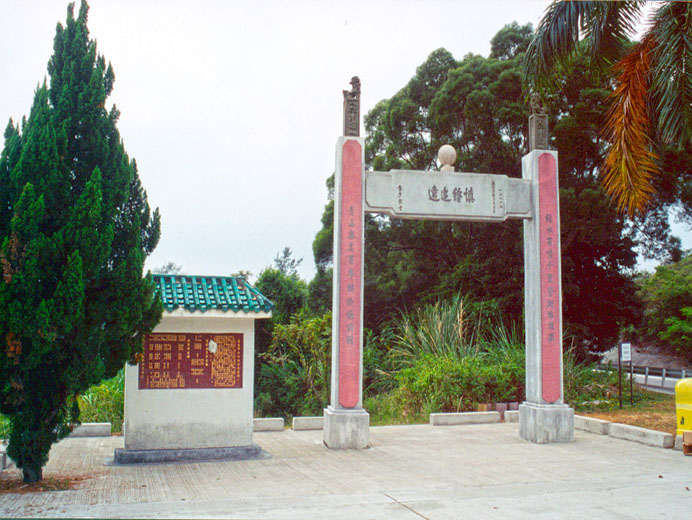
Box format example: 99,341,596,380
519,150,574,444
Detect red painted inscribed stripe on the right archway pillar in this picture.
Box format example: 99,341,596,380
538,153,562,403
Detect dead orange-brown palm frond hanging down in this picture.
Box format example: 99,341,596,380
602,33,657,214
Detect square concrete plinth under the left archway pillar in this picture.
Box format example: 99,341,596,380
324,406,370,450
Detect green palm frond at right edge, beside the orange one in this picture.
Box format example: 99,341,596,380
650,2,692,146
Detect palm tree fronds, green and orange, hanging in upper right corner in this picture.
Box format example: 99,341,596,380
524,0,692,215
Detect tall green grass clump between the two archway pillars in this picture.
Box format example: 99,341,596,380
392,297,525,416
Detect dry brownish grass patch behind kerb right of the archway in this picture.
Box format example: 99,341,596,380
578,389,677,435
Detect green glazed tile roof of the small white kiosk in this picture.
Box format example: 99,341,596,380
153,274,274,312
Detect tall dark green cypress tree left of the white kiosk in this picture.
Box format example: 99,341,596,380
0,2,162,482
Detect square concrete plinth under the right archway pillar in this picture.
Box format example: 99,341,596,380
519,402,574,444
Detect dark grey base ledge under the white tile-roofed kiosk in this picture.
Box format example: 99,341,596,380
114,443,271,464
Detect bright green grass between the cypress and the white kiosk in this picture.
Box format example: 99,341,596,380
77,368,125,432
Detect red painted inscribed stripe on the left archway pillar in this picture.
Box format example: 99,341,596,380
338,140,363,408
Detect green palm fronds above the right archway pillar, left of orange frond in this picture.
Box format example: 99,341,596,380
523,0,644,94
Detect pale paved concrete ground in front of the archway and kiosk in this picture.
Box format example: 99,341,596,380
0,423,692,520
